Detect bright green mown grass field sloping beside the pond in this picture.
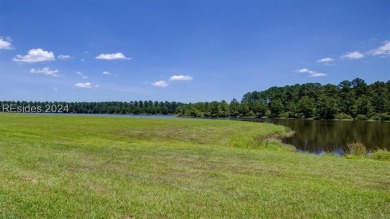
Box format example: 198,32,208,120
0,114,390,218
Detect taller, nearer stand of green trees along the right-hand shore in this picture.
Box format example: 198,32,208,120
176,78,390,120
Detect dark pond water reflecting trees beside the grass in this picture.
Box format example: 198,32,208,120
239,119,390,154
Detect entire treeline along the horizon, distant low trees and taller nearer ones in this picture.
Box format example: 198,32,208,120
1,78,390,120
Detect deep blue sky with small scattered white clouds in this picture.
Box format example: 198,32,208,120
0,0,390,102
